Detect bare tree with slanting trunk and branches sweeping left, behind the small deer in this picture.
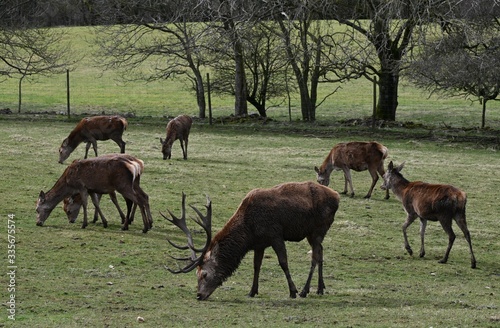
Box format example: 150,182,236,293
96,0,207,118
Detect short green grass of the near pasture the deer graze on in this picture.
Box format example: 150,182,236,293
0,115,500,327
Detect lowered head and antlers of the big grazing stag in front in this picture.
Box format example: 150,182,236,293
160,193,214,300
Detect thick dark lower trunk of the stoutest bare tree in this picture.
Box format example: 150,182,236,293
375,70,399,121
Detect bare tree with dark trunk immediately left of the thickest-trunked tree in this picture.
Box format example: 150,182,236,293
271,0,359,121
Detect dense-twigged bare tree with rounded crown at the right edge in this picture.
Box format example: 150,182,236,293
408,2,500,128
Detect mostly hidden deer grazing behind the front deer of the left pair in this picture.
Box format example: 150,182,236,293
63,154,144,228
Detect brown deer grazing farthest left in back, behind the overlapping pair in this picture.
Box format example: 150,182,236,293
59,115,128,163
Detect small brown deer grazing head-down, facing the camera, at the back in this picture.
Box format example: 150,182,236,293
160,115,193,159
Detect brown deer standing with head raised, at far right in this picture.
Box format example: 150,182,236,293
381,161,476,268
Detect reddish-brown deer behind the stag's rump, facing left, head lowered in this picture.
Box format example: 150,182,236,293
314,141,389,199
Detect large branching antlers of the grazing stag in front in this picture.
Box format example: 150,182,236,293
160,192,212,273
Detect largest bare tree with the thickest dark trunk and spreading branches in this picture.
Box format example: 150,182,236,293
331,0,463,120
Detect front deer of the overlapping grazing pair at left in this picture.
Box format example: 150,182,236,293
36,155,153,233
